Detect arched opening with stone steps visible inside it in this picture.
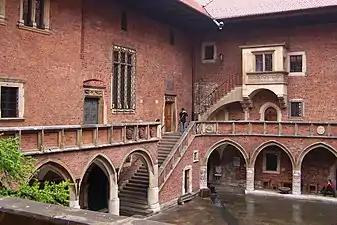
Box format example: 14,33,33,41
118,151,157,216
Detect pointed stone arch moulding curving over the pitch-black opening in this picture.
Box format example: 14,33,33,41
79,153,118,191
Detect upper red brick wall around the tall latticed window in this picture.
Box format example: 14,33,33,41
0,0,192,126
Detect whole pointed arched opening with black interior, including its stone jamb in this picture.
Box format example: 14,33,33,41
80,155,118,214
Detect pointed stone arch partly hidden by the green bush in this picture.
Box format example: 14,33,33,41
30,159,75,183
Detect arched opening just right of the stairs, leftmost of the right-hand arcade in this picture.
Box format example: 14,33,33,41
207,143,246,190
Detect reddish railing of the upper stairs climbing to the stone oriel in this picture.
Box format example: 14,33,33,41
197,76,242,115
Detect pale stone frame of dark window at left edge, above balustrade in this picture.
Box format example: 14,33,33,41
0,79,24,120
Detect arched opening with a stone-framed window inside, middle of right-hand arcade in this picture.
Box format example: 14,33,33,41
254,144,293,191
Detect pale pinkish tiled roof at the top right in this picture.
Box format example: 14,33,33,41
198,0,337,19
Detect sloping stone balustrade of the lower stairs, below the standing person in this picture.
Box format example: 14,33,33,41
158,121,196,190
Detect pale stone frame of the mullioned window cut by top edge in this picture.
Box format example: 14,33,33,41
18,0,50,33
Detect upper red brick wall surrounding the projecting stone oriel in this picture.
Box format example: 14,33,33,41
196,24,337,121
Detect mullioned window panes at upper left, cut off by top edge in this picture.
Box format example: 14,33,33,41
20,0,50,29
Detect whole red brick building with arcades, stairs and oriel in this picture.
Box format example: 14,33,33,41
0,0,337,218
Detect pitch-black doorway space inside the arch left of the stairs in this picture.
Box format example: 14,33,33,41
88,165,109,212
